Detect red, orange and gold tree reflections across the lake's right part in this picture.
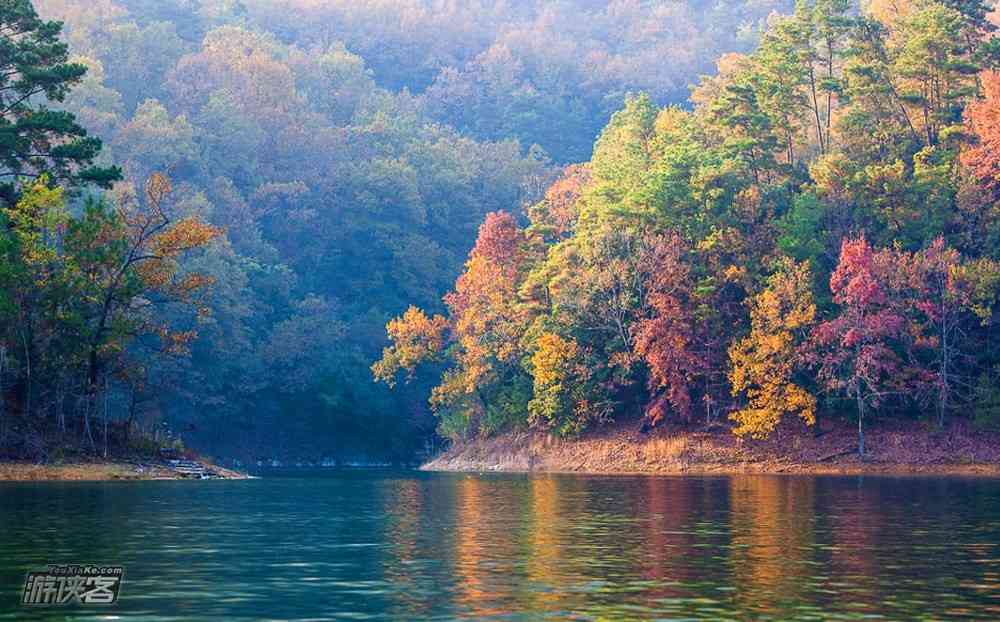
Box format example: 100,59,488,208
374,475,1000,620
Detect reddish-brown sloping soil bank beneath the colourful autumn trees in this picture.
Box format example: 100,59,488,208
421,421,1000,476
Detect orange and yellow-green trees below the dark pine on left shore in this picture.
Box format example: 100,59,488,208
0,176,221,449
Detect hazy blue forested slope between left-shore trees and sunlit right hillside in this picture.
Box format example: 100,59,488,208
35,0,792,459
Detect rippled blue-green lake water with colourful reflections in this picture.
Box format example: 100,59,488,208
0,471,1000,621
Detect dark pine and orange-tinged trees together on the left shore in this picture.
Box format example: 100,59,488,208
0,0,220,457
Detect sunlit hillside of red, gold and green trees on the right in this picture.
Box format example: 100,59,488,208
373,0,1000,452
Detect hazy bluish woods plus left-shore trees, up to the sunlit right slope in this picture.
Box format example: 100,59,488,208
0,0,791,458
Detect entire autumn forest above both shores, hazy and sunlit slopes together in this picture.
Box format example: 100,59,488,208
0,0,1000,461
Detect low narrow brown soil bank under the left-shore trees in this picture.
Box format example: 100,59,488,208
0,462,247,481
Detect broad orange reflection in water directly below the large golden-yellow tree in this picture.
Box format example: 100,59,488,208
729,475,816,614
